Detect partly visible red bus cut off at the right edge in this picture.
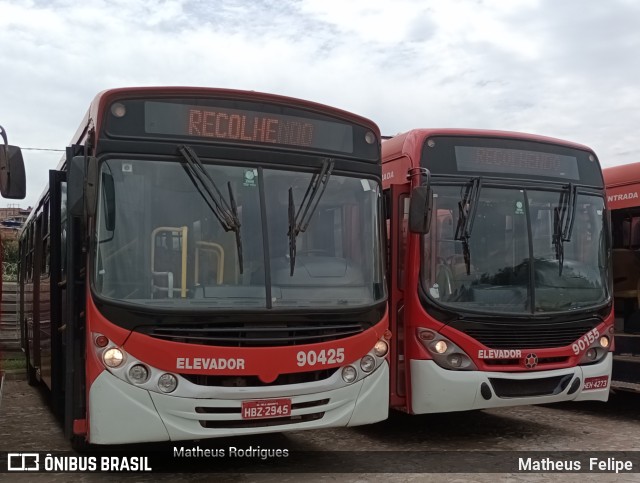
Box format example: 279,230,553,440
602,163,640,392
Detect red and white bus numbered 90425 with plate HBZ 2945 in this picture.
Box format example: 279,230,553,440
20,87,390,447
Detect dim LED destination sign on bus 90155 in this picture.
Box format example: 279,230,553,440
455,146,580,179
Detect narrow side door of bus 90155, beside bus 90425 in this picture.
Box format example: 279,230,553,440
386,183,410,409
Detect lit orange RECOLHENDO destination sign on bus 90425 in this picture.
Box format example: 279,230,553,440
144,101,353,153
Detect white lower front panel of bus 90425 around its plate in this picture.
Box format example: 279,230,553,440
89,361,389,444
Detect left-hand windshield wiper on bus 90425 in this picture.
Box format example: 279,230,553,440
178,145,243,274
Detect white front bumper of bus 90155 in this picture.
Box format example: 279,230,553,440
411,353,613,414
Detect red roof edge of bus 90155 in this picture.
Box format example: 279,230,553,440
382,128,595,162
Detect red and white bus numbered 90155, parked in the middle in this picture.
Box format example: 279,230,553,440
382,129,613,414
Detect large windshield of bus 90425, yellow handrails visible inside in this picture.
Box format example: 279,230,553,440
93,159,386,310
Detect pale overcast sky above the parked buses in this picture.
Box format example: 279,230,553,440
0,0,640,207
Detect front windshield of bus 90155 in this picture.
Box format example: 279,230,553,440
421,185,609,314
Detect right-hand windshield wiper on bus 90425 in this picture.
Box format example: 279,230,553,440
287,159,334,276
